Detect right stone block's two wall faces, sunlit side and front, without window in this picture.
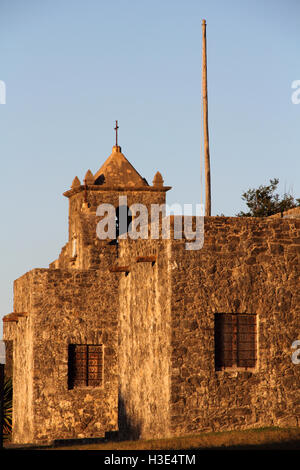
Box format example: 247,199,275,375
119,217,300,437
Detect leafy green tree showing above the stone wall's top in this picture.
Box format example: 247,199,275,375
236,178,300,217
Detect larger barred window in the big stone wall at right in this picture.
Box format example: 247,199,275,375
215,313,256,370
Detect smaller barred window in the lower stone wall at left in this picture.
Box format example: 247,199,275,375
68,344,103,389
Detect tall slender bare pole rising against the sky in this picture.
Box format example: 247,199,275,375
202,20,211,216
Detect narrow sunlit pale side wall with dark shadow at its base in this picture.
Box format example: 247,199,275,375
119,240,171,439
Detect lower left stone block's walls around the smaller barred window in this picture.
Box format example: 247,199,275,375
4,269,118,443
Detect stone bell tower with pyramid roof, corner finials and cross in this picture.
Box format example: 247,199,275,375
58,125,171,269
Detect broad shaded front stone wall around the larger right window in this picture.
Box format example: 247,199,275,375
170,217,300,435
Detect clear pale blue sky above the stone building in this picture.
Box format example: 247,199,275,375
0,0,300,333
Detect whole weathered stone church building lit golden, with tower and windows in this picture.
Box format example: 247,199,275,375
3,140,300,443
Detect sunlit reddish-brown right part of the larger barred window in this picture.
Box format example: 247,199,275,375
236,314,256,368
